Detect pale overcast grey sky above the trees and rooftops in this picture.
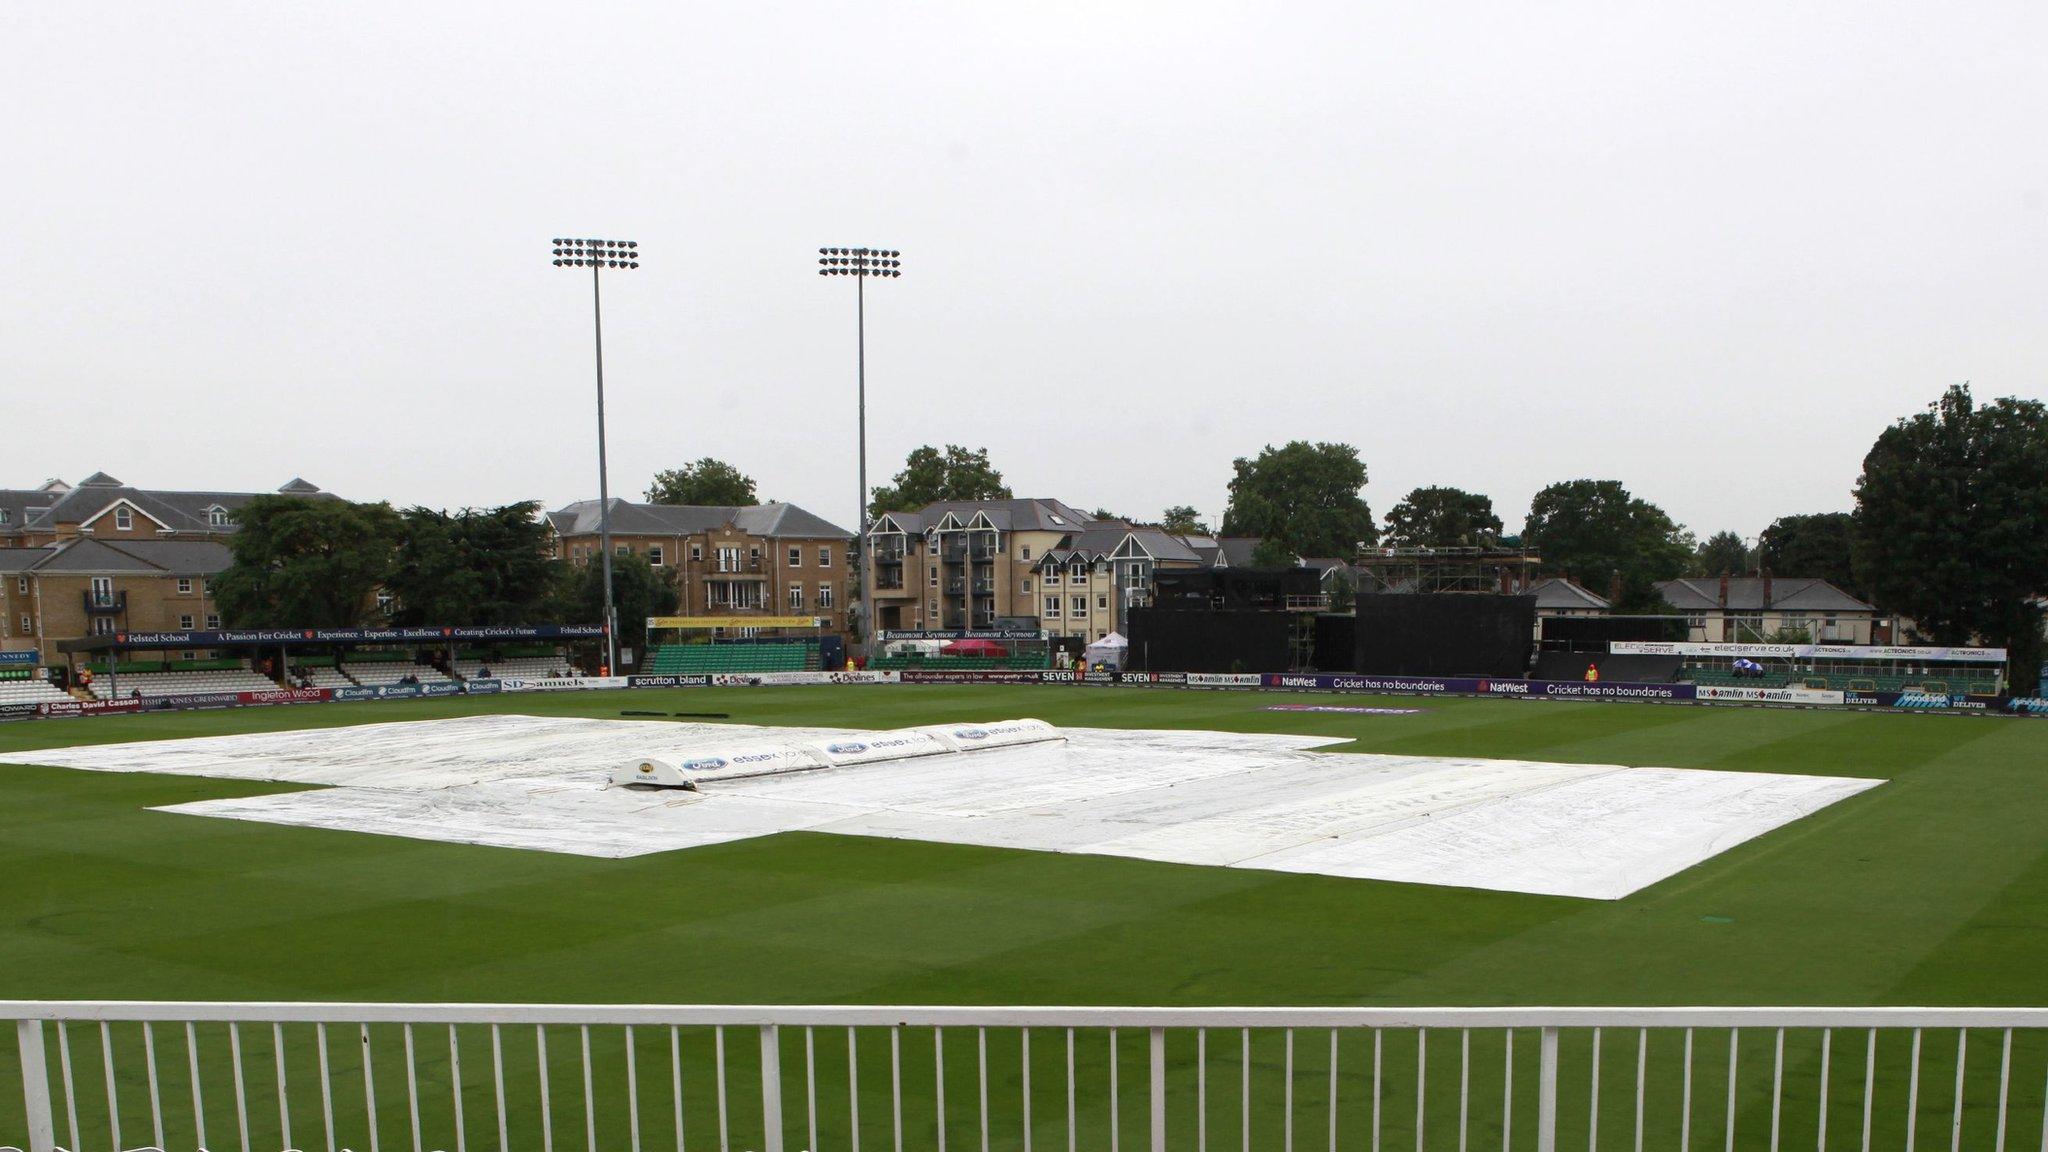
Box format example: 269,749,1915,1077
0,2,2048,535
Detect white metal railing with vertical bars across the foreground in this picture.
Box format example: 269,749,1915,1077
0,1000,2048,1152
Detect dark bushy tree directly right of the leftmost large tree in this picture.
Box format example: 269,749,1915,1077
385,500,555,625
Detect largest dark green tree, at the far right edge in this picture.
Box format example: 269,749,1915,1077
1853,383,2048,685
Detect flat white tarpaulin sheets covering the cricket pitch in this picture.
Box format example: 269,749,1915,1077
8,715,1880,900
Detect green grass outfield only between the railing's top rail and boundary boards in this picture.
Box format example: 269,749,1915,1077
0,687,2048,1004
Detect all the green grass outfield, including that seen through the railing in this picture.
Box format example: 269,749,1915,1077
0,687,2048,1152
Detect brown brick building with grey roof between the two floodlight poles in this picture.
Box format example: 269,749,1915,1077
547,498,854,633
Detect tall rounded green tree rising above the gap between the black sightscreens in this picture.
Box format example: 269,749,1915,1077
1223,441,1378,560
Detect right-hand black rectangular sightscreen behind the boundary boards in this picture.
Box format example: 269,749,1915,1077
1356,592,1536,676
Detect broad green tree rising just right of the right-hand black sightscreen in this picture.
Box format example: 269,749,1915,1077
1522,480,1694,613
